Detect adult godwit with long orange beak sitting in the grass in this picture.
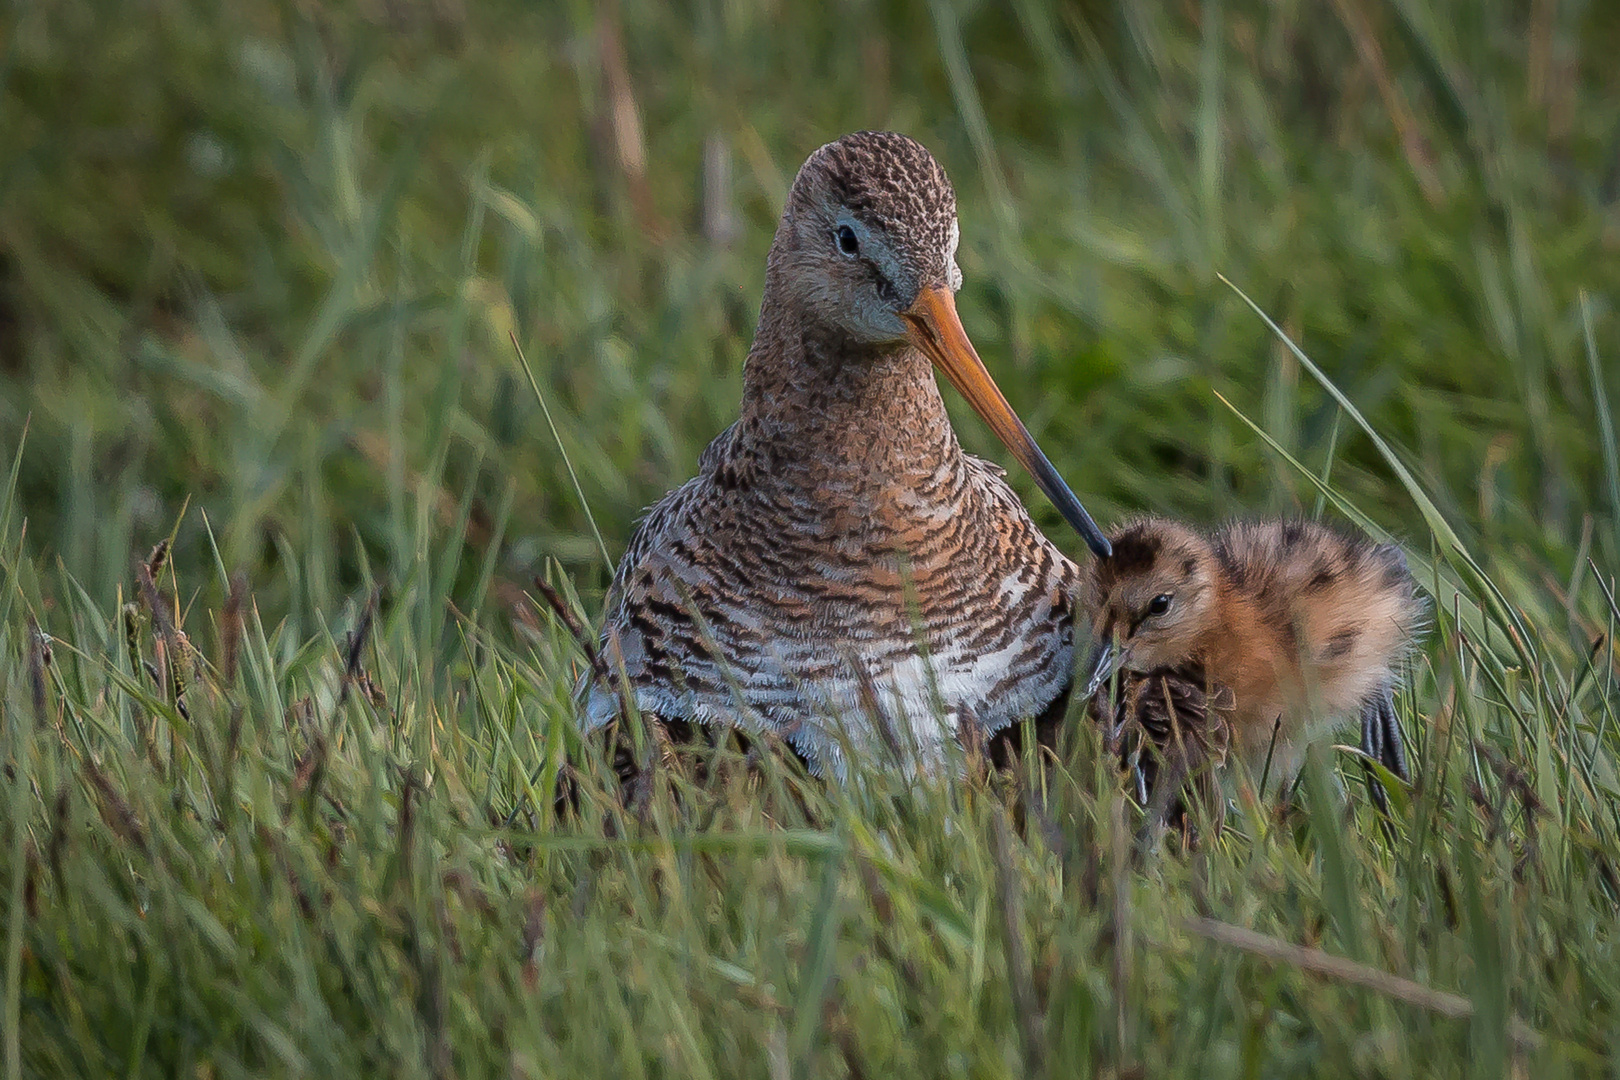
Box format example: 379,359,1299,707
583,131,1108,774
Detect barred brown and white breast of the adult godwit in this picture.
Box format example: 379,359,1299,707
598,458,1076,771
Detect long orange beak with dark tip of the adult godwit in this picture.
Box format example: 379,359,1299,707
902,288,1113,559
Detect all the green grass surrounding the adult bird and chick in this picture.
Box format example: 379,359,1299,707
0,0,1620,1080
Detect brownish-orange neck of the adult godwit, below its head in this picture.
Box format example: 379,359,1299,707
739,291,962,481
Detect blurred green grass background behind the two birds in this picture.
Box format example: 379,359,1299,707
0,0,1620,625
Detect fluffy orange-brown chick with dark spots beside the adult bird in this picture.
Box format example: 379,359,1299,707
1084,518,1424,805
